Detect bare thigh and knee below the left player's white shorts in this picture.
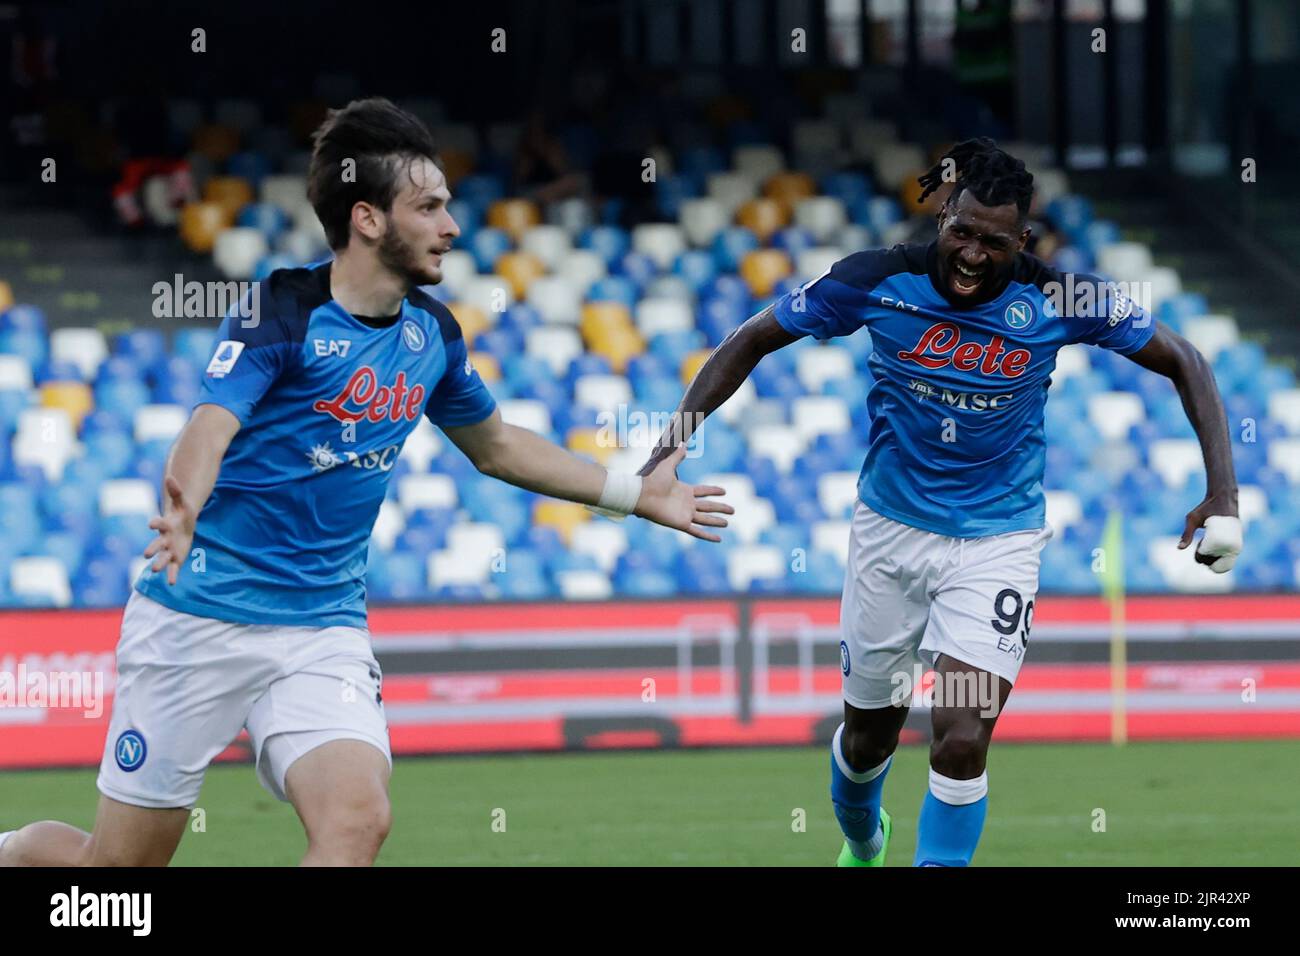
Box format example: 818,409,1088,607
282,734,391,840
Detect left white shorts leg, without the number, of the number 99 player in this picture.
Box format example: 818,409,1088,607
840,502,939,710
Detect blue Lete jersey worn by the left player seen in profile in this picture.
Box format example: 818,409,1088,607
135,263,495,627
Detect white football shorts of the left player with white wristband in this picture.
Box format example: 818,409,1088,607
99,591,393,808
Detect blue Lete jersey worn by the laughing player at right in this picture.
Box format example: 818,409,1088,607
775,242,1156,537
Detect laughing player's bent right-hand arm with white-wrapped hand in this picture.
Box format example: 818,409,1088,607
1128,323,1242,572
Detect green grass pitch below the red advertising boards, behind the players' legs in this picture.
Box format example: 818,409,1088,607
0,740,1300,866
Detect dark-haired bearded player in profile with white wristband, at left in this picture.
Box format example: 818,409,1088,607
0,99,731,865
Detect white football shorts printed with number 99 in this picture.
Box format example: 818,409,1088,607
840,501,1052,710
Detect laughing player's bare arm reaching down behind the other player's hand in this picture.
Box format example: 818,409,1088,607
638,306,798,475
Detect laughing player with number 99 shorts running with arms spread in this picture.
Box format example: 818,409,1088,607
641,139,1242,866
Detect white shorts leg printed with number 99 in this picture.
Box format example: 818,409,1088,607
920,529,1050,710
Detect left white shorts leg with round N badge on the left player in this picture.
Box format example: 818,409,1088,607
98,592,274,810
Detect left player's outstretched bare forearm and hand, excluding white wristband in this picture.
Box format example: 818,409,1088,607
443,410,733,541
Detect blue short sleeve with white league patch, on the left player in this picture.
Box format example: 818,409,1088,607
195,312,294,424
